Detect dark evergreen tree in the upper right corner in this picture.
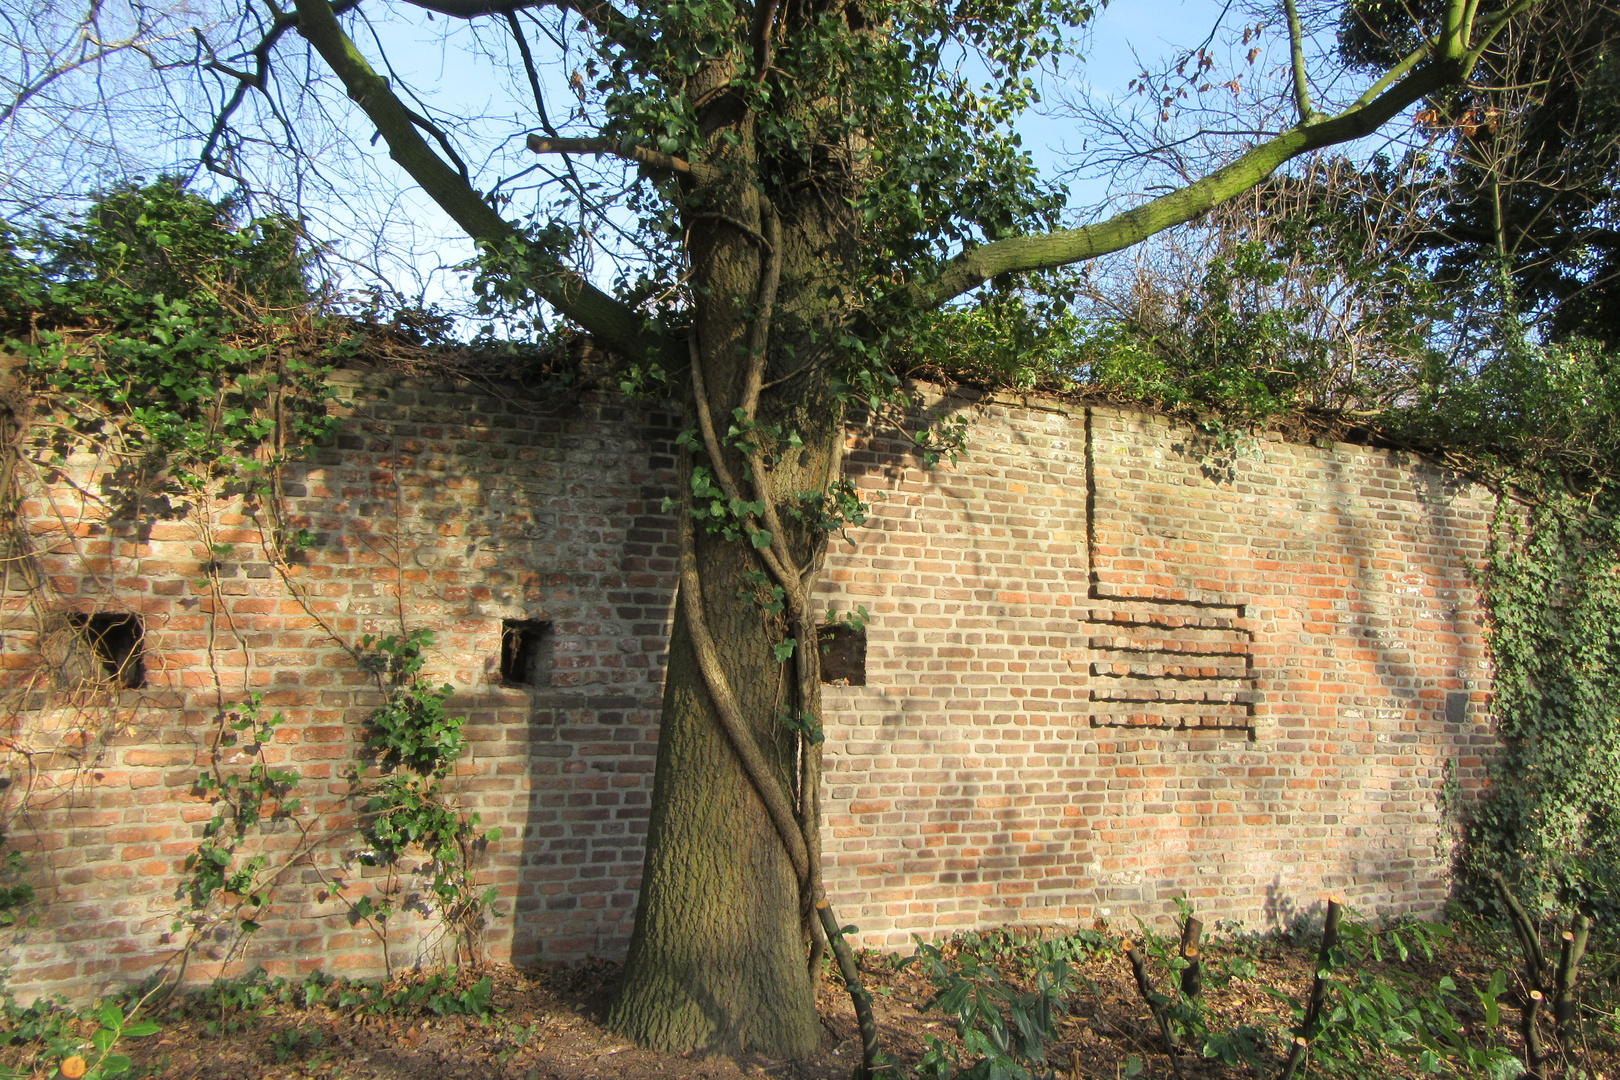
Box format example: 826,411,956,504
1338,0,1620,342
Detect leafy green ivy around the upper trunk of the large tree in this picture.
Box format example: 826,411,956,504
463,0,1094,338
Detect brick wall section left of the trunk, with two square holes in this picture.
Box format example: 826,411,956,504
0,372,677,1001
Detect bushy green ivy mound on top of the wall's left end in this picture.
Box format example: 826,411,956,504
0,178,330,499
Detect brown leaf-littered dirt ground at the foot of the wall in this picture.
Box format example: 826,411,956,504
0,936,1620,1080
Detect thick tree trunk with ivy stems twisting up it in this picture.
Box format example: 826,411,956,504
609,29,855,1057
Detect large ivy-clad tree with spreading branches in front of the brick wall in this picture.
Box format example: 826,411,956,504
15,0,1534,1056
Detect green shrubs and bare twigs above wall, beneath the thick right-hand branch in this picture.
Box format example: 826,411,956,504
896,159,1445,426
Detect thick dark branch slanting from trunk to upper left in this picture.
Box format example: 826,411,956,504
296,0,663,359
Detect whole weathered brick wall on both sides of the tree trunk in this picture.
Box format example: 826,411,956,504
0,372,1494,999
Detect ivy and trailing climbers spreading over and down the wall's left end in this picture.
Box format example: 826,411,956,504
0,178,499,978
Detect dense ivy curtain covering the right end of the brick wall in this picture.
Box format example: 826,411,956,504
1464,487,1620,920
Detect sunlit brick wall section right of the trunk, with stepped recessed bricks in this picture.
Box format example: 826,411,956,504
821,402,1492,947
